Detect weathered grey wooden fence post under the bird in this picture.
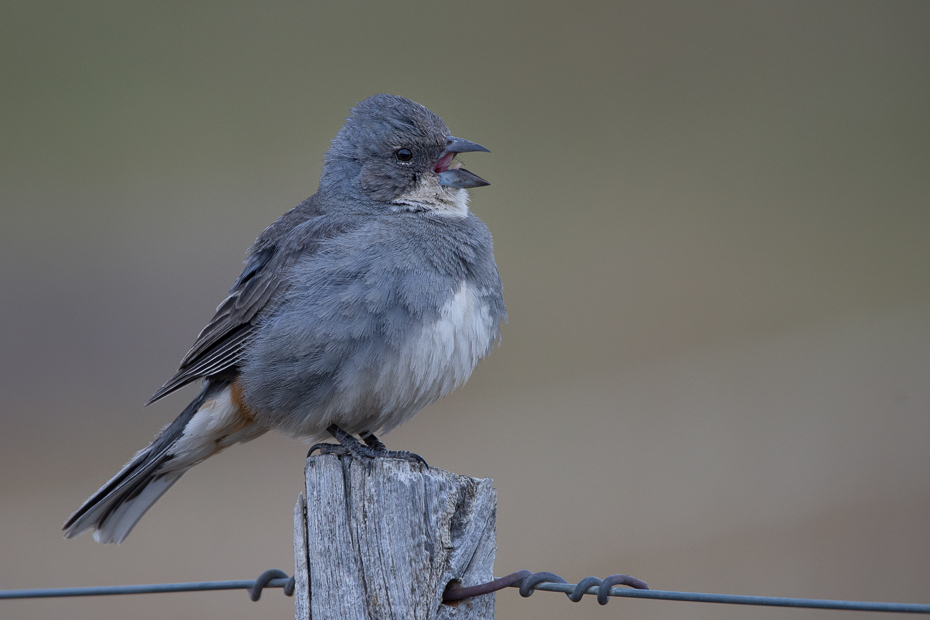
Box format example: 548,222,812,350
294,455,497,620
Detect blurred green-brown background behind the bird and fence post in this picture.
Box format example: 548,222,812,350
0,0,930,619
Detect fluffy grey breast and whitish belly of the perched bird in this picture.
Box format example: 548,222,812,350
242,216,504,437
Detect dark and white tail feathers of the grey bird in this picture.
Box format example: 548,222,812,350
62,381,264,544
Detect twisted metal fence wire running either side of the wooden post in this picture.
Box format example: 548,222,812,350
0,569,930,614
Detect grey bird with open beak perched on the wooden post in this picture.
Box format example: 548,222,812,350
63,94,507,544
